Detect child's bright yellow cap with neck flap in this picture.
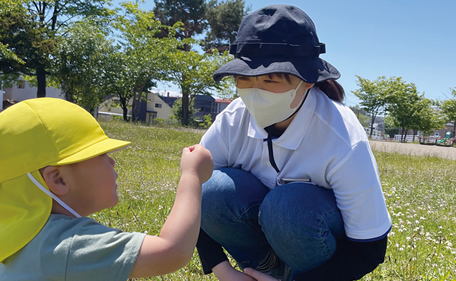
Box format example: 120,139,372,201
0,98,130,262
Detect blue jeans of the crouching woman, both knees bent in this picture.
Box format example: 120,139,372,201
201,168,346,276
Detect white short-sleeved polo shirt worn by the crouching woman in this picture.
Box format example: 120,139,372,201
201,87,391,241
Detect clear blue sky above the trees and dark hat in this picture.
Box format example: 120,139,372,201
114,0,456,106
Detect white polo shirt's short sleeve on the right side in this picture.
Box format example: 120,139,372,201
327,141,391,238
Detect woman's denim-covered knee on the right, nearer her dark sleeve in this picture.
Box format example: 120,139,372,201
259,183,345,272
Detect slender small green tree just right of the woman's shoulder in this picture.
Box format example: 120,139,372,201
352,75,390,137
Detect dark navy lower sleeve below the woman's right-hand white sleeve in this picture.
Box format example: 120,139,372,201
295,237,388,281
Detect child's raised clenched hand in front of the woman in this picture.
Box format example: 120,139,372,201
181,144,214,183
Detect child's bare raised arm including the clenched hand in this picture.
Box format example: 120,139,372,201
130,145,214,277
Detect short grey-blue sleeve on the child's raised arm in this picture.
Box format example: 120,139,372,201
66,220,145,281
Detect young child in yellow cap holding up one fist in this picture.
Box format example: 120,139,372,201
0,98,213,281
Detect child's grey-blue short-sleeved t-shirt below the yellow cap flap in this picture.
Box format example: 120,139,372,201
0,214,145,281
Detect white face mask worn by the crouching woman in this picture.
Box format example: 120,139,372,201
237,81,307,128
